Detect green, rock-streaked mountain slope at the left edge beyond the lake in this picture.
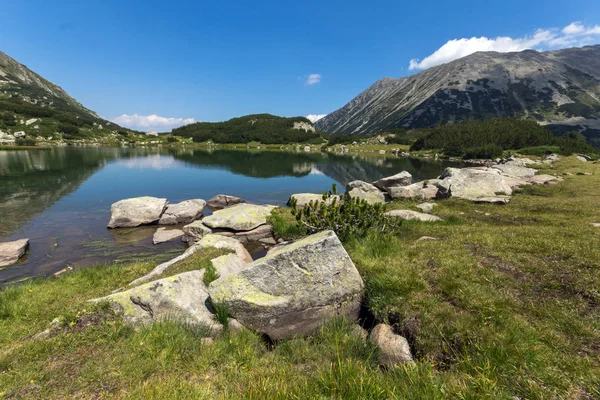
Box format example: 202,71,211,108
0,52,120,138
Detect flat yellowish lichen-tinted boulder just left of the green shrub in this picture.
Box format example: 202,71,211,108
202,203,275,231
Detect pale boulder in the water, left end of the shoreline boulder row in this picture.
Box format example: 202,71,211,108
108,196,167,228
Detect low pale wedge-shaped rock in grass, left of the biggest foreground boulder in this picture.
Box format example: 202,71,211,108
92,270,223,336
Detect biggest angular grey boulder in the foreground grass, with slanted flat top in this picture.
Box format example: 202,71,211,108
208,231,364,340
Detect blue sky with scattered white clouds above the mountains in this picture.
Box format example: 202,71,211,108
0,0,600,130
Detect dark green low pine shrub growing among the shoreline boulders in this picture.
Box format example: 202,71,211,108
290,184,401,241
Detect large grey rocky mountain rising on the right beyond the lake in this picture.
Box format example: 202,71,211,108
315,45,600,145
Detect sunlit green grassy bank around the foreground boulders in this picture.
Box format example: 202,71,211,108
0,158,600,399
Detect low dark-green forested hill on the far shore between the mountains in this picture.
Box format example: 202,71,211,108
171,114,324,144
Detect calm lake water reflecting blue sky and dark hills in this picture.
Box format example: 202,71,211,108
0,148,464,284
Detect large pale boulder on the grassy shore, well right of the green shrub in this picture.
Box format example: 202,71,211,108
436,167,512,202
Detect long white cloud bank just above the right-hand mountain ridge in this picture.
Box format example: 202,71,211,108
408,22,600,70
